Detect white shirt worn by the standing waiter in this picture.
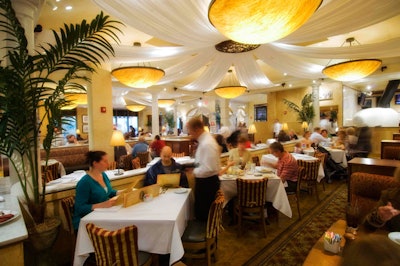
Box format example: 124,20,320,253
193,132,221,178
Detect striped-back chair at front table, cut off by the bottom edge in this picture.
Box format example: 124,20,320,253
86,223,152,266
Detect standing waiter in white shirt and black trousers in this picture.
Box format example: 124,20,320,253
187,118,221,221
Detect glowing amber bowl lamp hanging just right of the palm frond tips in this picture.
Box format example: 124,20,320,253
111,66,165,88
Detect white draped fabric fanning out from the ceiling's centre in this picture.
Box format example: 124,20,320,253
93,0,400,92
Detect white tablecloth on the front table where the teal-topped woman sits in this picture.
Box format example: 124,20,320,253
74,189,191,265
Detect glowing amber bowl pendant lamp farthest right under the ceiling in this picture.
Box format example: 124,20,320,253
322,59,382,81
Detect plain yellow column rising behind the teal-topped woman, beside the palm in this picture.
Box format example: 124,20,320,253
87,69,114,157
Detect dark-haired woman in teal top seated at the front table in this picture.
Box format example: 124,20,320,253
72,151,118,230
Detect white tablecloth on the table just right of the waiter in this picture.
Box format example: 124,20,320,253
219,170,292,218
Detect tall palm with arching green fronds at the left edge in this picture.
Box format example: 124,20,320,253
0,0,120,223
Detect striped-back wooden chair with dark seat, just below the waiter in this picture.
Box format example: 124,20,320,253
182,190,225,265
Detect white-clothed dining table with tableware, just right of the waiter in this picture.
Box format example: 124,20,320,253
219,166,292,218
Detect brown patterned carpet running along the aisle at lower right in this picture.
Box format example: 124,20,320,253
244,184,347,266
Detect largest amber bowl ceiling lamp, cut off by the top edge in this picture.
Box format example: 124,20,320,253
208,0,322,44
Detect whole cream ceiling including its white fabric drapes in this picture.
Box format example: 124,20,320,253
35,0,400,106
